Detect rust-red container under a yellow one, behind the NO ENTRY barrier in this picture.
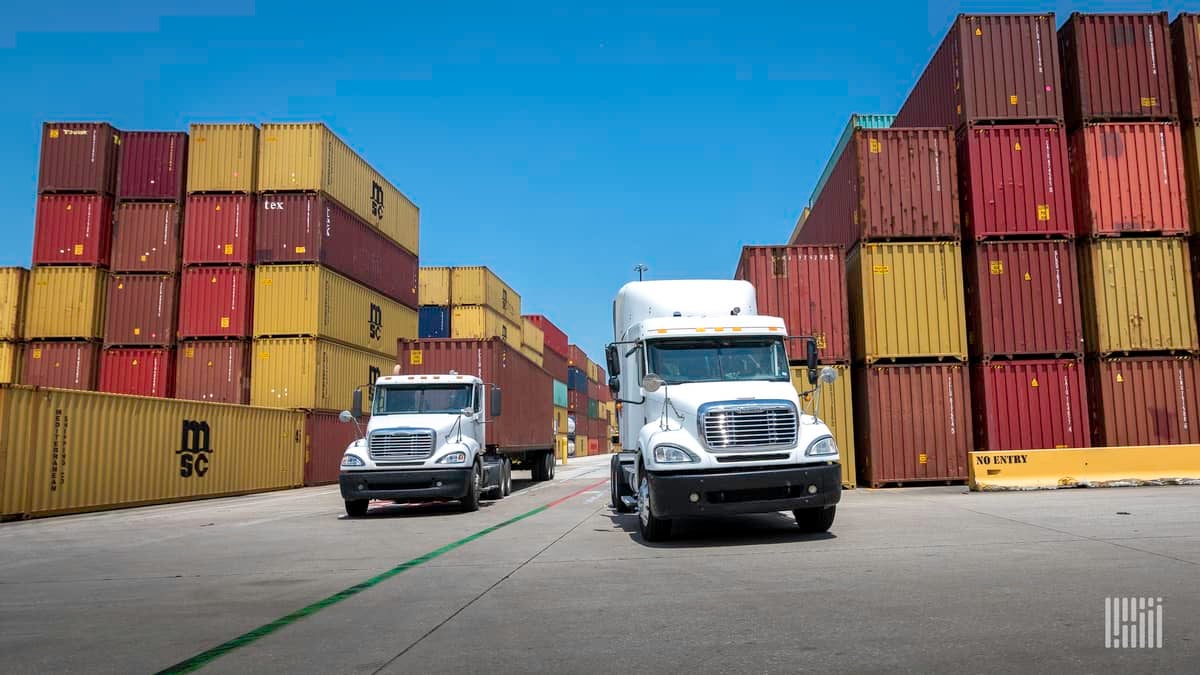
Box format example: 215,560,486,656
1087,357,1200,447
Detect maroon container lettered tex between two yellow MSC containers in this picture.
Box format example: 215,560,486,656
254,193,419,309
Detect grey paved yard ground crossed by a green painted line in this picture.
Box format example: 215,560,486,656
0,458,1200,673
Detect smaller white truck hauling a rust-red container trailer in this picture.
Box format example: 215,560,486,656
338,338,556,516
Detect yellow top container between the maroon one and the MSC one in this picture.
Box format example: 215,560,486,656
187,124,258,193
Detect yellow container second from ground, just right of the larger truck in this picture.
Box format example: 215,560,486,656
846,241,967,363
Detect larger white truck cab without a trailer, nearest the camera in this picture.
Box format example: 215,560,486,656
605,281,841,542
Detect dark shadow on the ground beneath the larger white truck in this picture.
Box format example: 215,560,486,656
605,509,838,549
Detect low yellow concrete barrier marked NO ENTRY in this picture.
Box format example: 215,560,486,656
971,446,1200,491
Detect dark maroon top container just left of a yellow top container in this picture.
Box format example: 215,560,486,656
116,131,187,202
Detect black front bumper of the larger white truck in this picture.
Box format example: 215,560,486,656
647,464,841,518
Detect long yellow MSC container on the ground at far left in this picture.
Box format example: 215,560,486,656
0,386,305,516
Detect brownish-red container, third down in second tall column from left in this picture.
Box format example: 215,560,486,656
104,275,179,347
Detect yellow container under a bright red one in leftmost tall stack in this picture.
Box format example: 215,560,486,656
25,267,108,340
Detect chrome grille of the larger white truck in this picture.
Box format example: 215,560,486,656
700,401,799,452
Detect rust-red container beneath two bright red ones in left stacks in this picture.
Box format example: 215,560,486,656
175,340,251,405
